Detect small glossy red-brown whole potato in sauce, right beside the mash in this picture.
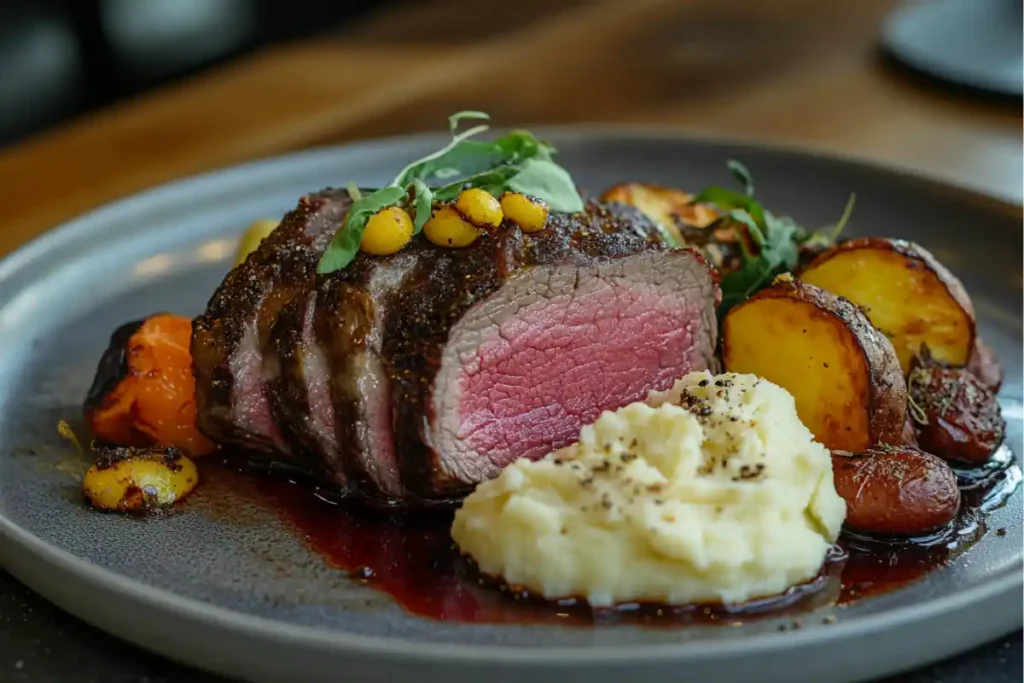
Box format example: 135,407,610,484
833,446,961,536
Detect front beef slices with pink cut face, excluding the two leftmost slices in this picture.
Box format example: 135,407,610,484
314,203,718,502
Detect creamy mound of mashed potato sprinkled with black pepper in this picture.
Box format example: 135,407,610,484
452,373,846,605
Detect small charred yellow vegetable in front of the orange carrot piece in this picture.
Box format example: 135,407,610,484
82,449,199,512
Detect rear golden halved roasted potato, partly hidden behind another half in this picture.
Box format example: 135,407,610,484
799,238,975,375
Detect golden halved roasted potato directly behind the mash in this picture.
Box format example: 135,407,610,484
722,278,906,452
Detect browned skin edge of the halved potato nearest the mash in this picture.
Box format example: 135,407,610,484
737,279,906,444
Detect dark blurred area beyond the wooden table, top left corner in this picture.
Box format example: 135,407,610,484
0,0,394,145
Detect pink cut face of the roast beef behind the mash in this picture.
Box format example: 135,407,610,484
435,255,714,481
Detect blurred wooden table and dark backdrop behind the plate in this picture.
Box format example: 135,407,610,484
0,0,1024,253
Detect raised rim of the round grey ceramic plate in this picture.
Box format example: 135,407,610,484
0,125,1024,667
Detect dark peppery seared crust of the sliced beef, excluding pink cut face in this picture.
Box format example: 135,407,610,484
193,191,721,505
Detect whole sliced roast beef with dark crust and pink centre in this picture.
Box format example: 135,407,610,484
194,195,719,505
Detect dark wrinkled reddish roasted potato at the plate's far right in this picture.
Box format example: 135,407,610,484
907,347,1007,465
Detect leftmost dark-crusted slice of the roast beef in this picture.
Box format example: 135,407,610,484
193,190,351,457
